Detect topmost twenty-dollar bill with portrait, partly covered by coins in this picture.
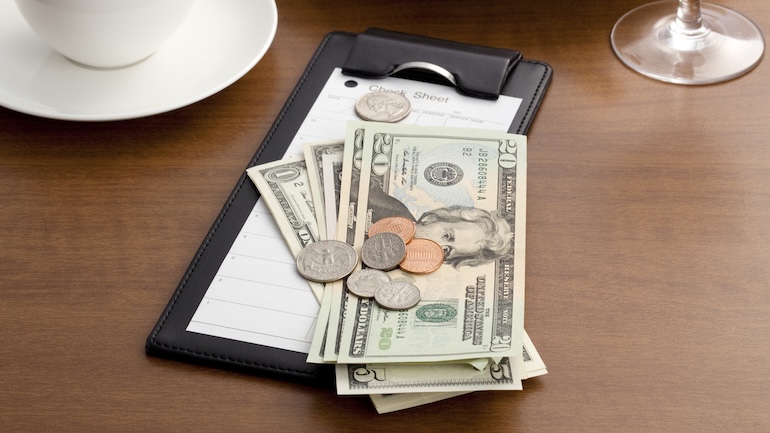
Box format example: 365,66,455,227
327,122,527,364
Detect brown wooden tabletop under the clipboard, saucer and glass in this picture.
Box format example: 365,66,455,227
0,0,770,433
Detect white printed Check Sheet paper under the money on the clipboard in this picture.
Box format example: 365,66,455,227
187,68,522,353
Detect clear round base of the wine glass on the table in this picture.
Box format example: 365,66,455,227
610,0,765,84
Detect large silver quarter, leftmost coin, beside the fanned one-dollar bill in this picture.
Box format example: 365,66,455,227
297,240,358,283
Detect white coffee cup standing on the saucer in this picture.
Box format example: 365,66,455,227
16,0,193,68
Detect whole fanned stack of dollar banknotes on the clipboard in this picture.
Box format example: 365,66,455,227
247,121,547,413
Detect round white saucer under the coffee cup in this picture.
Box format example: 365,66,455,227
0,0,278,121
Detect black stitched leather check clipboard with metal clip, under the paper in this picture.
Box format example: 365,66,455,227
145,29,552,386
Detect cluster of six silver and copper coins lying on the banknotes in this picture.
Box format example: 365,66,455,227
297,217,444,310
